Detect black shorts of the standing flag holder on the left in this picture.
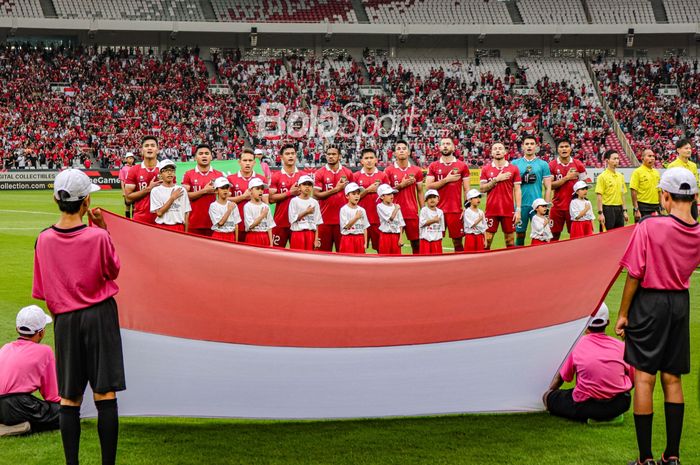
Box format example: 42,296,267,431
54,297,126,399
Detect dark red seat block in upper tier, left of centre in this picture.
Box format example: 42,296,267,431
211,0,357,23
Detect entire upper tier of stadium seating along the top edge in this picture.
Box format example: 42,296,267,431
0,0,700,25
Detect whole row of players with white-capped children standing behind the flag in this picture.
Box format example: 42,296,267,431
124,136,628,253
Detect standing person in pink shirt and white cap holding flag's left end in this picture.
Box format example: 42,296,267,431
32,169,126,465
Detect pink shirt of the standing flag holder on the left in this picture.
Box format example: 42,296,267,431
32,225,120,315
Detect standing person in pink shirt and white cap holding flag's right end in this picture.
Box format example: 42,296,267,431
615,168,700,465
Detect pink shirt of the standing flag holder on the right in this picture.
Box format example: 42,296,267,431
620,216,700,291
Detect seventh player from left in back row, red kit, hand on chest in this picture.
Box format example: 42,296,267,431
384,140,423,255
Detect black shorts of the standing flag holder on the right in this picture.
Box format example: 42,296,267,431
625,287,690,376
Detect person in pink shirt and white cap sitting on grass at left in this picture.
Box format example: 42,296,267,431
0,305,61,436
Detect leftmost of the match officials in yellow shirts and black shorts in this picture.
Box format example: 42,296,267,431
595,150,629,232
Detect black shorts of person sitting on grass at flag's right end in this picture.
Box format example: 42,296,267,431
547,389,632,421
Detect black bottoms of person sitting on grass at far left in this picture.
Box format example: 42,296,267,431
0,394,60,433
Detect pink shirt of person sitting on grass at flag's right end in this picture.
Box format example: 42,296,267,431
559,333,634,402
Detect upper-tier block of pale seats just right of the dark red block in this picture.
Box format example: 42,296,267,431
362,0,513,24
